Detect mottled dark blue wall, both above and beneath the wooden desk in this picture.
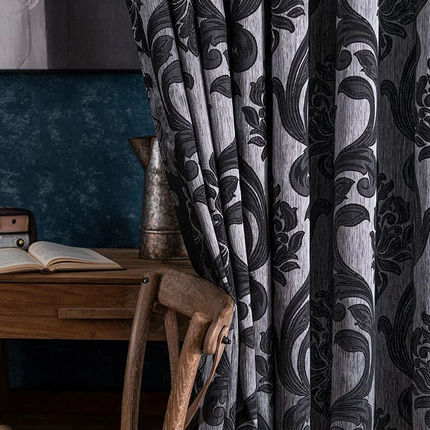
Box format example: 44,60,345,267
0,74,168,389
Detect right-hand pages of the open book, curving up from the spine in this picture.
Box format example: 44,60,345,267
28,241,116,267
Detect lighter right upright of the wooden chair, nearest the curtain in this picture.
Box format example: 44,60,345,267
163,313,211,430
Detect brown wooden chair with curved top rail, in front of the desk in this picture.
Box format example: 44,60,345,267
121,270,233,430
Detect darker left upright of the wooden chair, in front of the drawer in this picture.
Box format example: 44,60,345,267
121,273,160,430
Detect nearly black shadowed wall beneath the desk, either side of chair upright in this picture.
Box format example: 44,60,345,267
9,340,170,391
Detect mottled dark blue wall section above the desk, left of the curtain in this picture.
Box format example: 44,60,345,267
0,73,153,248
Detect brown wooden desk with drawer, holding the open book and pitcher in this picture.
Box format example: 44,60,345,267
0,249,194,430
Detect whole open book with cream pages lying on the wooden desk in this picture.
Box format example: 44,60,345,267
0,242,122,274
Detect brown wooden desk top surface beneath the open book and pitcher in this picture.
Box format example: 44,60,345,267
0,248,195,285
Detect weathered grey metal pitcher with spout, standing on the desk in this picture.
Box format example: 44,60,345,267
128,136,188,260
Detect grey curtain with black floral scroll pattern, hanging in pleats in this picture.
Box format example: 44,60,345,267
127,0,430,430
